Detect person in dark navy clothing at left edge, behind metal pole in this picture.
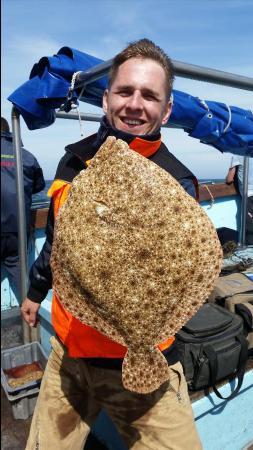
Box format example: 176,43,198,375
1,117,45,304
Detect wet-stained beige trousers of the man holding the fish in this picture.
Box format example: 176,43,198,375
26,337,202,450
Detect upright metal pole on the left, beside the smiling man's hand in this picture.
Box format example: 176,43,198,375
11,107,38,344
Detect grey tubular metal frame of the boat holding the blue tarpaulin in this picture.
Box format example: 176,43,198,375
12,60,253,343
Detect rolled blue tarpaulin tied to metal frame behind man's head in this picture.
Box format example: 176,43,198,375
8,47,253,157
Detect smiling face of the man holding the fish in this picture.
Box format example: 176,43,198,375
103,58,171,136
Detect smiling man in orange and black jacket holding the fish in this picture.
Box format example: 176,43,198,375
22,39,201,450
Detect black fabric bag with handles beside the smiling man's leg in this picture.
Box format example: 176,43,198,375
176,303,248,400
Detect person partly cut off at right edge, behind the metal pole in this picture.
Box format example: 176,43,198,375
226,155,253,245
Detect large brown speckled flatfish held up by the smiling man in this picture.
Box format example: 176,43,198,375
51,137,222,393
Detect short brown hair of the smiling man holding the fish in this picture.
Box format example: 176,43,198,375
108,38,175,97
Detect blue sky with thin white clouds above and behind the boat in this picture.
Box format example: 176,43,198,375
1,0,253,179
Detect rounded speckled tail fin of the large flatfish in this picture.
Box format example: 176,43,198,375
122,348,169,394
